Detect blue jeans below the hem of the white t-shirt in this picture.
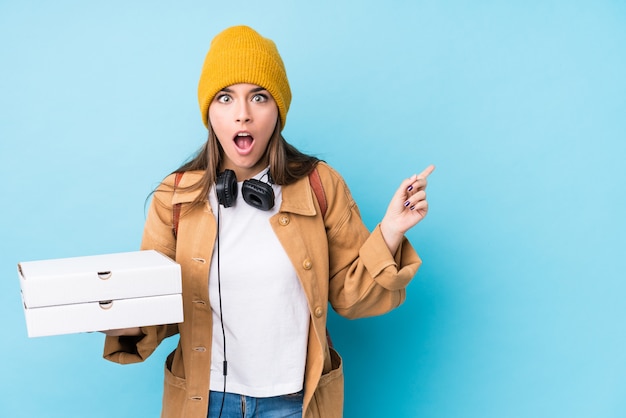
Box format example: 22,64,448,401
208,391,304,418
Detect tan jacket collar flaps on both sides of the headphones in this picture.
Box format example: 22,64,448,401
172,171,317,216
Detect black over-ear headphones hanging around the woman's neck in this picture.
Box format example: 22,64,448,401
215,170,274,210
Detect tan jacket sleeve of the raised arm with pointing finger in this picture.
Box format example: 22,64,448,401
318,165,421,319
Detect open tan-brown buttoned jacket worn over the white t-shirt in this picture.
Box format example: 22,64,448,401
104,163,421,418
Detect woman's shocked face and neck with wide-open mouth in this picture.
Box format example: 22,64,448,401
209,84,278,181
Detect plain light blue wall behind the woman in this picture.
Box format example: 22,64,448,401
0,0,626,418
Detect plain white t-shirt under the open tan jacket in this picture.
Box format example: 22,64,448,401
209,169,310,397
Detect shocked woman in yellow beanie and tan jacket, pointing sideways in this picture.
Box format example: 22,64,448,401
104,26,434,418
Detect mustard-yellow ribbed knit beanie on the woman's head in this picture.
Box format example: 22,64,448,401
198,26,291,128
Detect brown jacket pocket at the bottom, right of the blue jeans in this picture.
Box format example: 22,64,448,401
306,348,343,418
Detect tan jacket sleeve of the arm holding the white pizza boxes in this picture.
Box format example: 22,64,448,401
103,176,178,364
